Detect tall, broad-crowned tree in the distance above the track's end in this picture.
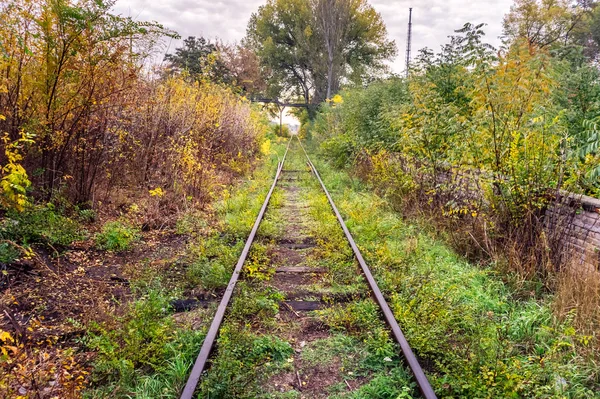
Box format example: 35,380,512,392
246,0,396,104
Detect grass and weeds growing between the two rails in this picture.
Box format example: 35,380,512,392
195,142,416,399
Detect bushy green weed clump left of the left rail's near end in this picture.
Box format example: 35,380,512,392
85,285,203,398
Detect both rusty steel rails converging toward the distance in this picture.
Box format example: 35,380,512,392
181,138,436,399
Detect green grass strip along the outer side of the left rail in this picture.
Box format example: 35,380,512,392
84,138,290,398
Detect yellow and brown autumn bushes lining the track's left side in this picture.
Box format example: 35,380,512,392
0,0,265,209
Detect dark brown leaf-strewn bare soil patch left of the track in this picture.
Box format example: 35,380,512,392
0,230,186,345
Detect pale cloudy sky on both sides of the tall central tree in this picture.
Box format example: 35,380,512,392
115,0,512,72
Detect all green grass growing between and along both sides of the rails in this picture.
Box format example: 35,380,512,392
86,137,600,399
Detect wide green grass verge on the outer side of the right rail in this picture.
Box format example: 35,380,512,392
304,151,600,398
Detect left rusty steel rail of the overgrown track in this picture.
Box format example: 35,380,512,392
181,139,292,399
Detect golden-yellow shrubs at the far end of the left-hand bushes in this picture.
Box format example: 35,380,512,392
130,76,265,206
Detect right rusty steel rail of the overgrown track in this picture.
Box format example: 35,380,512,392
298,139,437,399
